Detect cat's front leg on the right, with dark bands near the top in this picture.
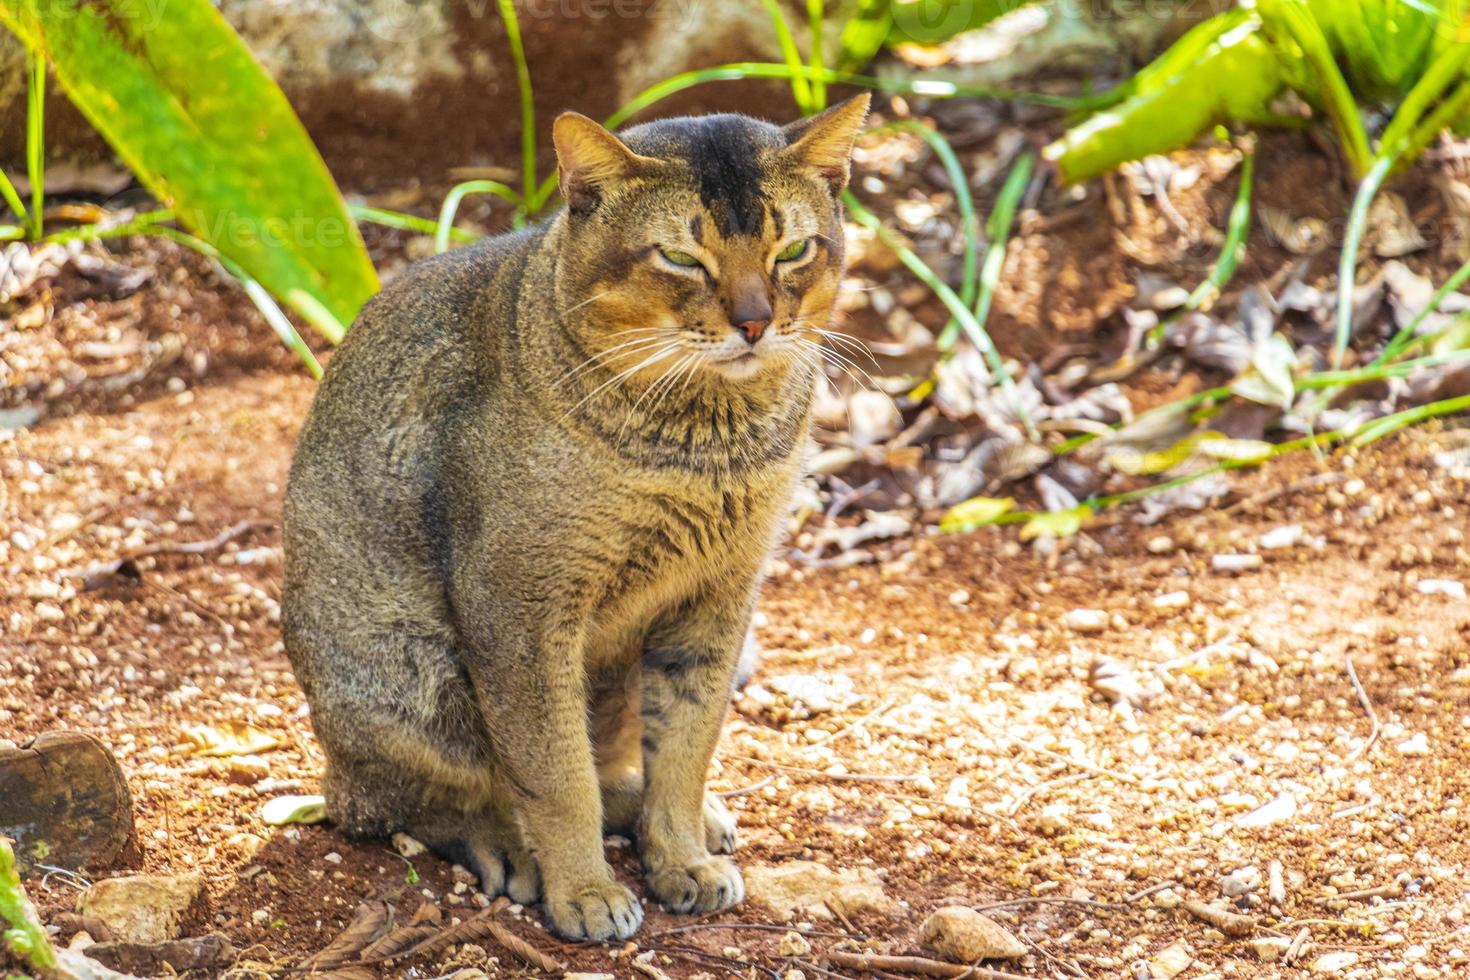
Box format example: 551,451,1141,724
638,582,754,912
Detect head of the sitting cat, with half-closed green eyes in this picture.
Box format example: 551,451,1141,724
553,94,869,383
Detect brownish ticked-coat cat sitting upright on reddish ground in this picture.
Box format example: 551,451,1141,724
282,96,869,940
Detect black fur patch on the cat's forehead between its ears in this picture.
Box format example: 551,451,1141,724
625,115,786,238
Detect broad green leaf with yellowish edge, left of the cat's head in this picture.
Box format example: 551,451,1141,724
0,0,378,341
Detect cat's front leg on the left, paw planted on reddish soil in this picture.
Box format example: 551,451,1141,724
456,587,642,940
